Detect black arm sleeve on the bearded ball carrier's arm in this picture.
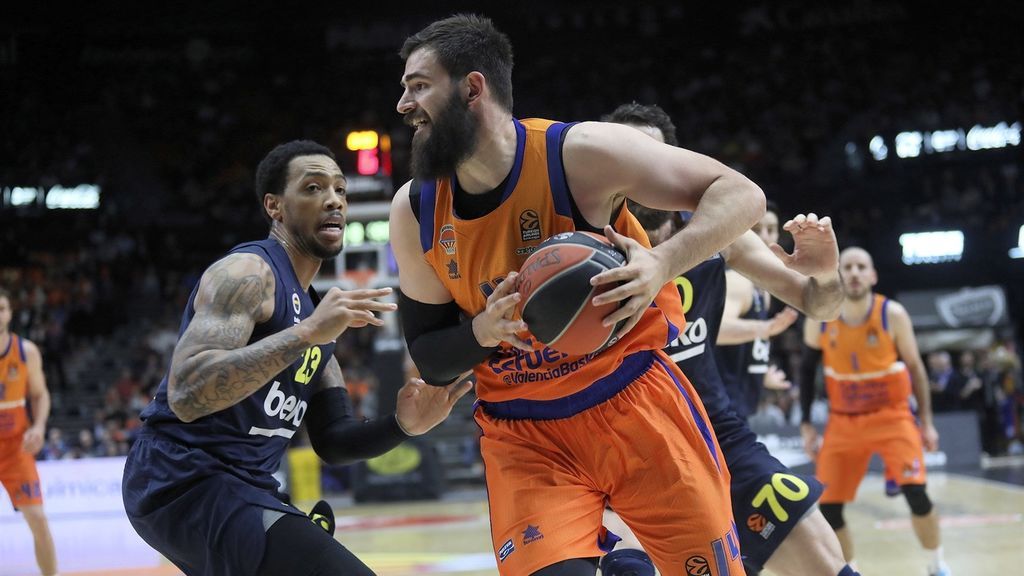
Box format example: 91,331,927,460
398,294,498,386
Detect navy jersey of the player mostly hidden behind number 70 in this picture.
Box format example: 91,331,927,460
715,287,771,418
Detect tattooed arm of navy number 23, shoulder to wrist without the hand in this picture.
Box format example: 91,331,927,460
168,256,309,422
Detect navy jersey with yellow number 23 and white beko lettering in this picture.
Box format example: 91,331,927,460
141,238,335,490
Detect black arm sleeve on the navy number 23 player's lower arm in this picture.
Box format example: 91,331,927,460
306,386,409,465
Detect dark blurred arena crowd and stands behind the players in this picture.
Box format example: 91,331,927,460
0,1,1024,459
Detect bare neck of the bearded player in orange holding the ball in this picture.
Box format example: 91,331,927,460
456,114,517,194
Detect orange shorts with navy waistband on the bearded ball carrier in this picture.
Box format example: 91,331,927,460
476,351,743,576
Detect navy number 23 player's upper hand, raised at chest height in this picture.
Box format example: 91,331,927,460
303,287,398,344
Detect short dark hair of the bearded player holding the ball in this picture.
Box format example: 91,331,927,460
398,14,512,112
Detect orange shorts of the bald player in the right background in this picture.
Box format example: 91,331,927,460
815,405,927,503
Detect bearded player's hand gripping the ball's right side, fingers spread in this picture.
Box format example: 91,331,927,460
590,225,668,342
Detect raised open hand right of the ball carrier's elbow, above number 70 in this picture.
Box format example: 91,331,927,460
769,212,839,278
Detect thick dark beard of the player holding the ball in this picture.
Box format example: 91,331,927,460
412,88,479,180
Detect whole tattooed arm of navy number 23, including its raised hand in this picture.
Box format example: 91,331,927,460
167,254,396,422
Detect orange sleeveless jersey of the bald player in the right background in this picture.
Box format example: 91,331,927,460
819,294,910,414
